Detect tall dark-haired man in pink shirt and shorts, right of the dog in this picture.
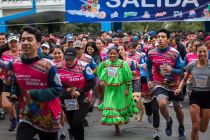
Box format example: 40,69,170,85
147,29,185,139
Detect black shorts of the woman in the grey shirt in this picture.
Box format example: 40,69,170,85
189,90,210,109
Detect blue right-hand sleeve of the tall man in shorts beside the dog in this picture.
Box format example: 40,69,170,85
171,54,184,75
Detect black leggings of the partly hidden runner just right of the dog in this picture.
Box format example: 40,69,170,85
144,98,160,128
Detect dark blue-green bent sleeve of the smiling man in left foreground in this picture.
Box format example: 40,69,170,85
29,66,63,102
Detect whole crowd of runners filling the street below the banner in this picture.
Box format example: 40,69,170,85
0,26,210,140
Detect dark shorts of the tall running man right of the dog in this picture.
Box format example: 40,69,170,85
154,87,184,106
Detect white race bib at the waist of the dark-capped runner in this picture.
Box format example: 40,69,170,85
64,99,79,111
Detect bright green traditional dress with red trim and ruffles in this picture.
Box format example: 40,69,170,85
97,59,138,125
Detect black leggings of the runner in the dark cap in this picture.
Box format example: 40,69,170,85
64,103,89,140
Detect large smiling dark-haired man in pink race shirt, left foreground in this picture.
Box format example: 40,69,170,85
0,26,62,140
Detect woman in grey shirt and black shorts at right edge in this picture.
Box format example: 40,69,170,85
176,43,210,140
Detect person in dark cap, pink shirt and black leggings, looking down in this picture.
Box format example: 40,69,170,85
58,47,95,140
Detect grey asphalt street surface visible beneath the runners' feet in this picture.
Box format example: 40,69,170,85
0,100,210,140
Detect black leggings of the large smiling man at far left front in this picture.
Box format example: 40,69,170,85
16,122,58,140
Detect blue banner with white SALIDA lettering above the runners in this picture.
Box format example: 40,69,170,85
66,0,210,22
